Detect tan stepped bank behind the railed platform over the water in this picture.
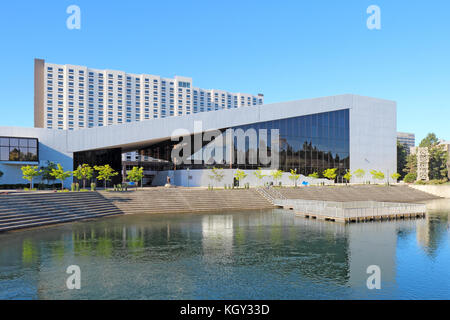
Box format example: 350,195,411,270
278,185,439,202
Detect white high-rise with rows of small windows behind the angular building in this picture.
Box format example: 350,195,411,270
34,59,264,160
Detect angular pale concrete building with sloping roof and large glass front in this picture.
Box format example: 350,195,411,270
0,94,397,187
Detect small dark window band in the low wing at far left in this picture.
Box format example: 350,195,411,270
0,137,39,161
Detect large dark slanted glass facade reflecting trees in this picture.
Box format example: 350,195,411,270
140,109,350,176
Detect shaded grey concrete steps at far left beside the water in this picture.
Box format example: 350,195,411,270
0,192,122,232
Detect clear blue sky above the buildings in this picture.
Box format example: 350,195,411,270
0,0,450,143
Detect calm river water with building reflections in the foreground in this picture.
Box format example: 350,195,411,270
0,200,450,299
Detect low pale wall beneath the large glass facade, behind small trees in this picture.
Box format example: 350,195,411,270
152,169,333,188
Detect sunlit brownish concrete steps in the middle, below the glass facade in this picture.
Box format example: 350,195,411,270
102,188,274,214
